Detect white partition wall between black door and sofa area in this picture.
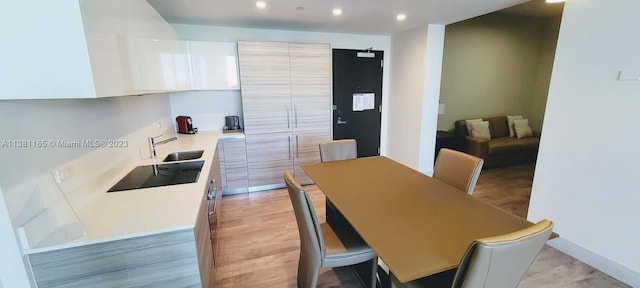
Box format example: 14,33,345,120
388,25,444,175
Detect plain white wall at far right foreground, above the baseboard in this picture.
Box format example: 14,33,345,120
528,0,640,287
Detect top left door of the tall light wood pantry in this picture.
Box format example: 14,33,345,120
238,41,290,79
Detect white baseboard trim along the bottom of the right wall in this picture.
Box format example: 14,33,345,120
548,238,640,287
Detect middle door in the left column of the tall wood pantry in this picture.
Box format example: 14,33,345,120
242,78,292,134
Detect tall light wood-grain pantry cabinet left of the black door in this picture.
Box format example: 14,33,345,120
238,41,331,191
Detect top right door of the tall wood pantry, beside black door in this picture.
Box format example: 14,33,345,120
289,43,331,78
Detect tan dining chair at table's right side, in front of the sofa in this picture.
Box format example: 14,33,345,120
433,148,484,195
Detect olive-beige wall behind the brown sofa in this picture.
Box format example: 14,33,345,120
438,13,557,131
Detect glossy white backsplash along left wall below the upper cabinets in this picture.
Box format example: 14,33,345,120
0,94,173,250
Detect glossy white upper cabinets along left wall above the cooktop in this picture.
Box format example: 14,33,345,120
0,0,191,99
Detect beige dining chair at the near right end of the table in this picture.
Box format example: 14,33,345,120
392,220,553,288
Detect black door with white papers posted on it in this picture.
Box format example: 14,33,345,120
333,49,384,157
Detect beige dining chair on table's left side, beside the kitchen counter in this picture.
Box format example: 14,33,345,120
284,170,378,288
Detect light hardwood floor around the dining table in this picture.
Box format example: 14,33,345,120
216,165,629,288
